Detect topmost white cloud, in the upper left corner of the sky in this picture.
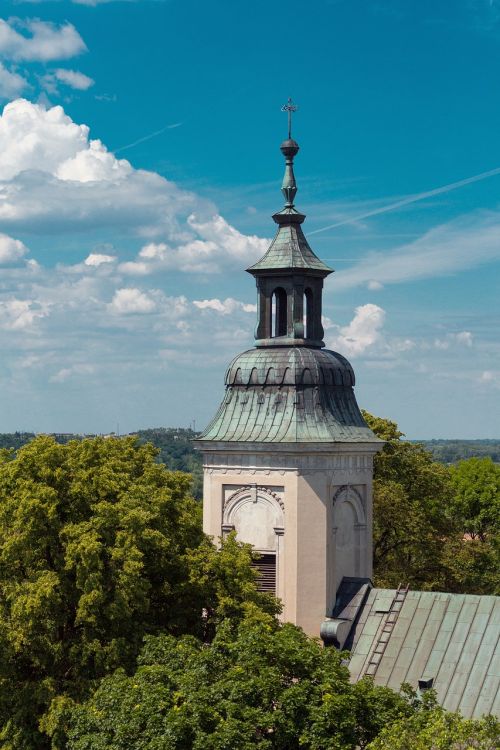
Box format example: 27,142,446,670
0,19,87,62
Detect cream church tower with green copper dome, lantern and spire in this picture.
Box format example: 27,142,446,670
193,100,382,636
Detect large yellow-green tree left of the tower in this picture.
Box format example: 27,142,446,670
0,437,276,750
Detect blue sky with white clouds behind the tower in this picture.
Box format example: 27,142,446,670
0,0,500,438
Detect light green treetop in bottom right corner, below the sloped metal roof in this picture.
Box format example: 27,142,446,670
367,706,500,750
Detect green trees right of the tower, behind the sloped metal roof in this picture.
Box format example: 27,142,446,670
364,412,500,594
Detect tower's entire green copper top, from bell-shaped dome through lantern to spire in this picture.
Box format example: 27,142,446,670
195,113,380,443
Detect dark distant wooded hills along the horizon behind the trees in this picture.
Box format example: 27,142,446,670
0,427,500,499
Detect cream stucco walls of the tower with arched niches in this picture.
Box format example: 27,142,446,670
202,443,379,636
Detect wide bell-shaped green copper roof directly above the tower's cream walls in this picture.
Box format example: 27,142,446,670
195,346,382,443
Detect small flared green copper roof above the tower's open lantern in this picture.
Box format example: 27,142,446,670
247,223,332,275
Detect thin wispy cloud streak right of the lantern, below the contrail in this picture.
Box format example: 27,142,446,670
336,211,500,289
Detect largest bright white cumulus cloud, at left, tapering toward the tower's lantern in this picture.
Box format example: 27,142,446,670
0,99,268,276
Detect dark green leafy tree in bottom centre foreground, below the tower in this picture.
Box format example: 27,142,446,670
59,619,412,750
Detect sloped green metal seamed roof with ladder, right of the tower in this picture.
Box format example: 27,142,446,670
349,589,500,718
